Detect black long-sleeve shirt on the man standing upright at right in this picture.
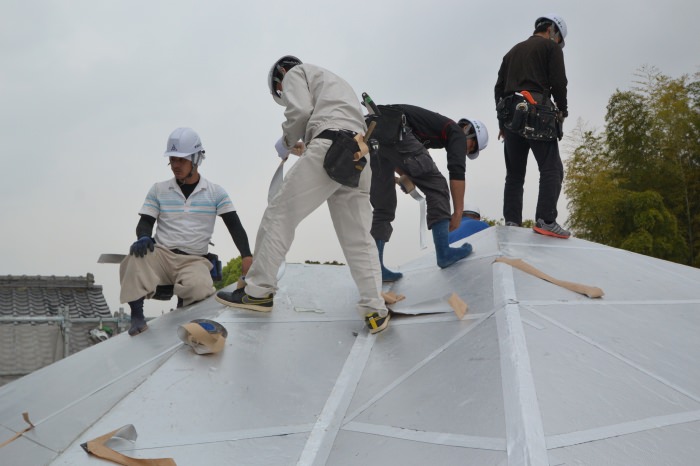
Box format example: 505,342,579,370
494,35,569,117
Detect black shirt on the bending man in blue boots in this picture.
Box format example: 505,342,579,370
394,104,467,180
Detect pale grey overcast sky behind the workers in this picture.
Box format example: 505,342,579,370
0,0,700,315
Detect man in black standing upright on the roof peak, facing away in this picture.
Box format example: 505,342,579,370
494,14,571,238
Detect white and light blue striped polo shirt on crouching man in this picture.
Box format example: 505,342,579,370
139,176,236,256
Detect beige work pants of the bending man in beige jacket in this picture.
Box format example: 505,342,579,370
246,139,387,317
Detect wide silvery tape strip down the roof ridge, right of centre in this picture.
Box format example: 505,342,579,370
493,263,549,466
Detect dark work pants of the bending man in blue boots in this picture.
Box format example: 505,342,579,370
369,131,452,241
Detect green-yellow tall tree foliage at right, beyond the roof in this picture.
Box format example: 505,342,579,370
564,68,700,267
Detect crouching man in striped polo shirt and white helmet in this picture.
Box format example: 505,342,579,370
119,128,253,336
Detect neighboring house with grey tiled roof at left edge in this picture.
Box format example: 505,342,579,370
0,273,117,385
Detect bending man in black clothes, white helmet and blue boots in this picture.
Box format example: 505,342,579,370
370,104,489,282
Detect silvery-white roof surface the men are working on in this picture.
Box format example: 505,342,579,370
0,227,700,466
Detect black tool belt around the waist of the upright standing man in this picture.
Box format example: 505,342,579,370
496,94,563,141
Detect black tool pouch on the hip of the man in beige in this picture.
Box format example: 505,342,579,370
316,129,369,188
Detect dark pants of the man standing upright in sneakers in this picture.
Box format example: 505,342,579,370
503,129,564,224
